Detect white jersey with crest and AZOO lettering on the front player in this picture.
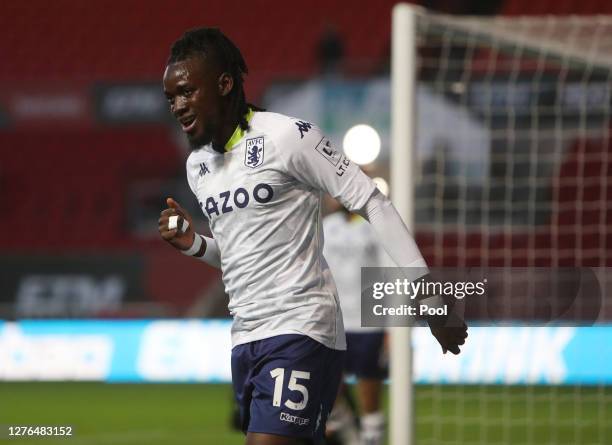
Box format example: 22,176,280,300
187,112,375,349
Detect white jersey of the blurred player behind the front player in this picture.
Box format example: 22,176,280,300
323,211,394,332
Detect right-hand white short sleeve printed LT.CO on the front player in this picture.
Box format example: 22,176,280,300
277,119,376,211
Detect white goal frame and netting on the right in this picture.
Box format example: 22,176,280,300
390,5,612,445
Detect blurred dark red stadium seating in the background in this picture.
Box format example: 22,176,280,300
0,0,612,312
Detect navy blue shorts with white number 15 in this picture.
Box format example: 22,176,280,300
232,335,344,443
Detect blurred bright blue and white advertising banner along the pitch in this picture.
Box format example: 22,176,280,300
0,320,612,385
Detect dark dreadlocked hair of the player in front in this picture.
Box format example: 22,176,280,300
168,28,263,130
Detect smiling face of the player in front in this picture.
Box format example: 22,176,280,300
164,57,221,148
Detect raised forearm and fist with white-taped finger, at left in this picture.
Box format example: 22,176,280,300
157,198,221,268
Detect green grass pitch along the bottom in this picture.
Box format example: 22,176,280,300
0,383,612,445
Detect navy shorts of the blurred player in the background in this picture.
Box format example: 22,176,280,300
344,332,388,379
